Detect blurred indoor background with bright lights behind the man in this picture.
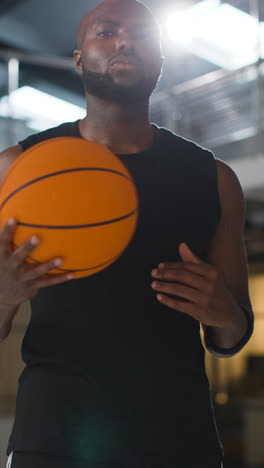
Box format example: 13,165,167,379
0,0,264,468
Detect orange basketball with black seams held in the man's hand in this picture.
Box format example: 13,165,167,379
0,137,138,278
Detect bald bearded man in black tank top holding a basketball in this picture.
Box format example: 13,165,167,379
0,0,253,468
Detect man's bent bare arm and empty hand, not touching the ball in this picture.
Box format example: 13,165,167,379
152,160,254,357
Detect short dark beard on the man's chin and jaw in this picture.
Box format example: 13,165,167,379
83,65,160,104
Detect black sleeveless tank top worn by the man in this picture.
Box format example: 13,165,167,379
7,121,223,468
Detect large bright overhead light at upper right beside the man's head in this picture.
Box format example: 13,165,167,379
167,0,263,70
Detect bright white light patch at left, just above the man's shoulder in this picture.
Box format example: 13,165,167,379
0,86,86,131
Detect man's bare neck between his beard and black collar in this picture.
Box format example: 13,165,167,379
79,96,154,154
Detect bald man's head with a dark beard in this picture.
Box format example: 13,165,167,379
74,0,163,104
